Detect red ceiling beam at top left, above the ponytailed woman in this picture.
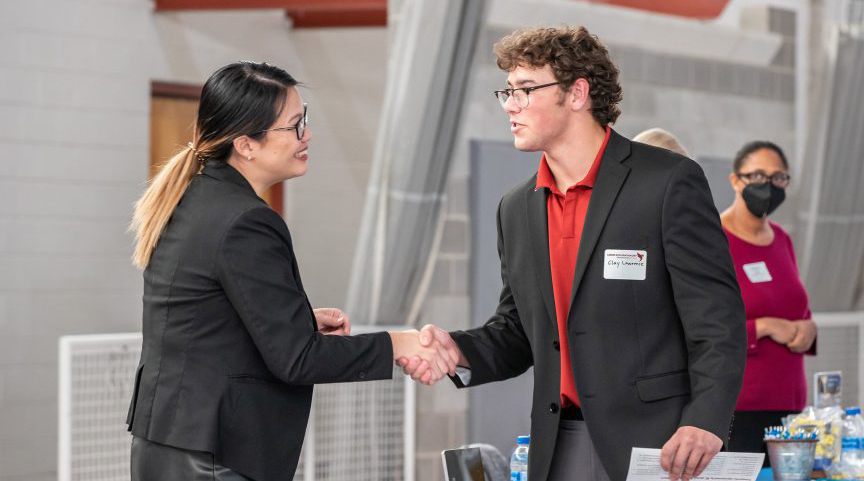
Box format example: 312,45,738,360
156,0,387,28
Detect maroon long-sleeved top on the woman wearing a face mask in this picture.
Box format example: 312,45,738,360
724,222,816,411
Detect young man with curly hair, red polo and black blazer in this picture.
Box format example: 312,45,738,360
399,28,745,481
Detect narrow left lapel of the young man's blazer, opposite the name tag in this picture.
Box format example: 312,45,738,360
525,179,558,323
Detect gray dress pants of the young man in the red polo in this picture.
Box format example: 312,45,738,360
549,419,609,481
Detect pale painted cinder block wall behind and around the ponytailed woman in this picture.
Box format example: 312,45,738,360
0,0,387,481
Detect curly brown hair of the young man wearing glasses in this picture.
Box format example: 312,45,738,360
493,27,621,127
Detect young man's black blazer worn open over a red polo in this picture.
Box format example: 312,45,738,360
453,131,746,481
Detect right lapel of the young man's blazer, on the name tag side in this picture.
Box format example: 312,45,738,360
567,130,630,312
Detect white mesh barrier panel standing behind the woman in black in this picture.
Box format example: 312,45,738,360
58,326,414,481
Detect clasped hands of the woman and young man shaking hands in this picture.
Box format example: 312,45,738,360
389,324,469,386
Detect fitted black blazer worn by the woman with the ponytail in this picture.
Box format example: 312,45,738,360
127,162,393,481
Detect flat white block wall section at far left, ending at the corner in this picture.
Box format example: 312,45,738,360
0,0,150,481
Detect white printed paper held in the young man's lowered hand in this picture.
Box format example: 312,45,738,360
627,448,765,481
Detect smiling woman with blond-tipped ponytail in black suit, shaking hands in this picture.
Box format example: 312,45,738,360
127,62,455,481
